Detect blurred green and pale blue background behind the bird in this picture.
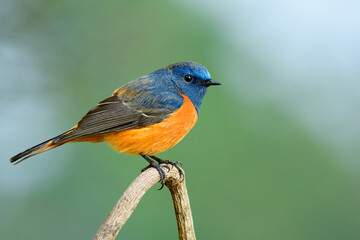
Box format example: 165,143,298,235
0,0,360,240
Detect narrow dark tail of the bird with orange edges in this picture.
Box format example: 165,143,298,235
10,132,69,165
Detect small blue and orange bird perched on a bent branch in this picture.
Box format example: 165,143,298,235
10,62,221,189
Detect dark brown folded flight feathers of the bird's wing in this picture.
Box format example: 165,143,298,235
56,94,170,142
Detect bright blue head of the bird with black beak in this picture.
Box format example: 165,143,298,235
152,62,220,113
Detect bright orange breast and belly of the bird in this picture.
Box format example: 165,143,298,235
104,95,198,156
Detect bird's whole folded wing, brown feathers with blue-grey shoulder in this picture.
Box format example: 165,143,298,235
56,88,182,142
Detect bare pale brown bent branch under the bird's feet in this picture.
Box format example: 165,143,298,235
94,165,196,240
